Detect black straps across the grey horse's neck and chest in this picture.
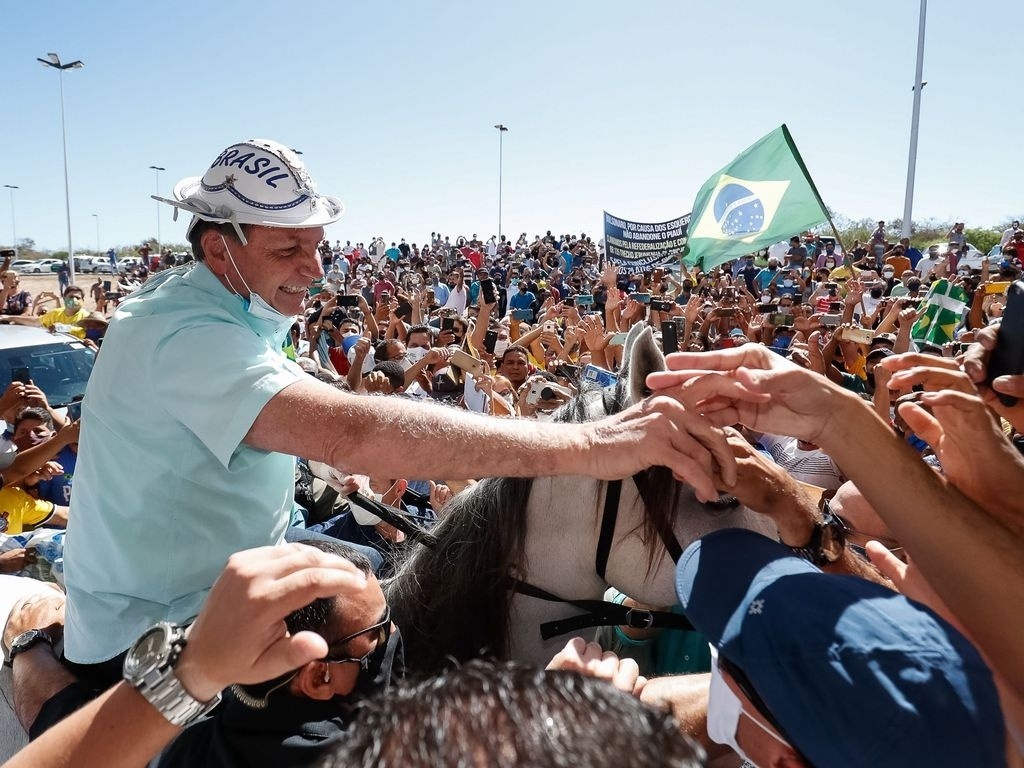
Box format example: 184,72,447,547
509,479,693,640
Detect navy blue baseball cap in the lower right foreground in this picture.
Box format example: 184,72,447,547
676,529,1005,768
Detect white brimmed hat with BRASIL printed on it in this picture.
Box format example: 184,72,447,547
153,138,345,245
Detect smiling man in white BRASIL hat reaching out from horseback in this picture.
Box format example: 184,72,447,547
56,139,734,696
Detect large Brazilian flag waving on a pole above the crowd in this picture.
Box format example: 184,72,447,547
686,125,828,270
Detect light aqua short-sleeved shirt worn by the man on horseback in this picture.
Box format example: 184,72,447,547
65,263,305,664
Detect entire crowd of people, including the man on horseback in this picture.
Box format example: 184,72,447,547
0,141,1024,766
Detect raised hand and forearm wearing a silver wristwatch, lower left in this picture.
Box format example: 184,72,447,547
6,544,366,768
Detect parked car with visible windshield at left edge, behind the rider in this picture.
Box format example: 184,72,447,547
0,326,95,417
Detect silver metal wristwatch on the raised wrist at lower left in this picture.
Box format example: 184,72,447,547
124,622,220,727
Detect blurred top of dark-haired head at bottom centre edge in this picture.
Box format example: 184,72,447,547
321,660,703,768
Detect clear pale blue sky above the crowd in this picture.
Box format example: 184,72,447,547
0,0,1024,249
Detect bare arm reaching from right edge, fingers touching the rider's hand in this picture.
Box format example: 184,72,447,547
647,344,1024,692
